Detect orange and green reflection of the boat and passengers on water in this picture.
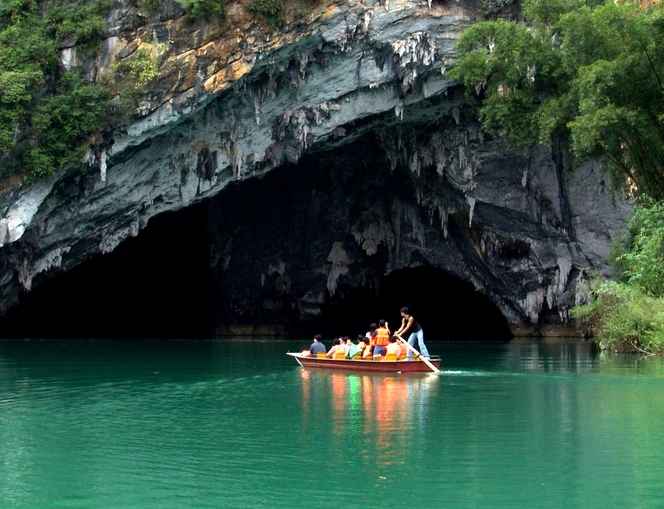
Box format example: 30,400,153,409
299,368,439,471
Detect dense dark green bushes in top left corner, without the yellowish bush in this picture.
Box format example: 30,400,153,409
0,0,109,181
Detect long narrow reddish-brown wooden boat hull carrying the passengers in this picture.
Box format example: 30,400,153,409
287,352,440,373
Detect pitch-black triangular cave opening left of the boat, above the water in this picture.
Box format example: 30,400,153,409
0,205,212,339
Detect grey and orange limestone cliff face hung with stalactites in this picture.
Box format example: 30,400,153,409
0,1,629,334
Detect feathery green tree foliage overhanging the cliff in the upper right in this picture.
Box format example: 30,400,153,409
451,0,664,199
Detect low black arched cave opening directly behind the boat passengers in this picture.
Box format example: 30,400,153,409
317,267,512,341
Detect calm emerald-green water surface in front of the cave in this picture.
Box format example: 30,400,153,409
0,341,664,509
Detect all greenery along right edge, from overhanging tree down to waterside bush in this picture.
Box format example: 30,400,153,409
451,0,664,353
